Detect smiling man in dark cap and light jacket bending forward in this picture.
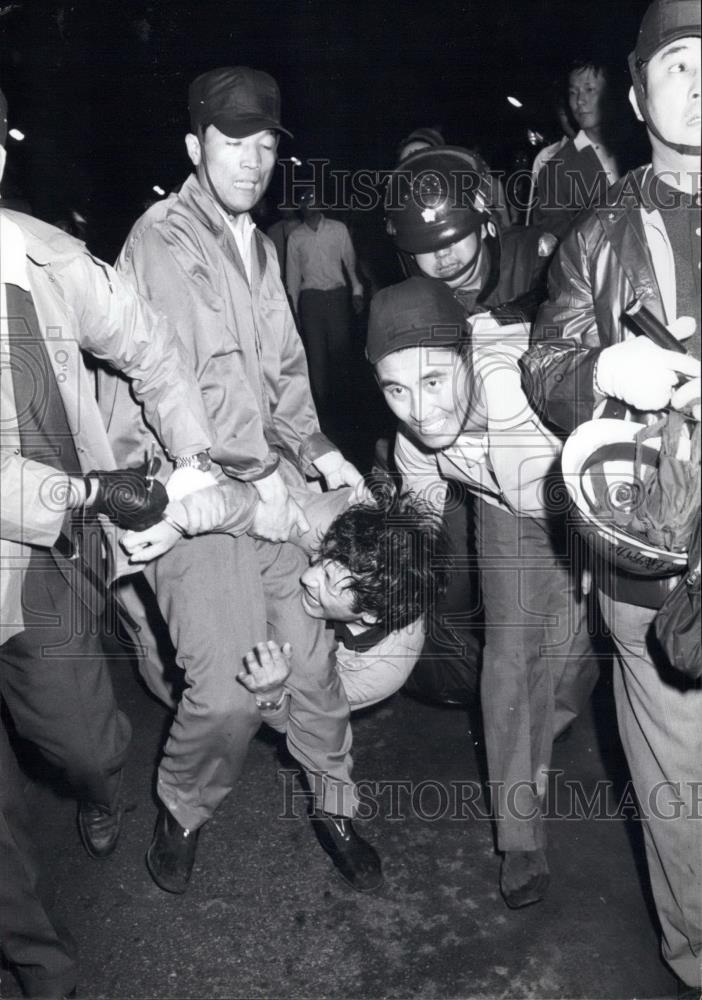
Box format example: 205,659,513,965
366,277,593,908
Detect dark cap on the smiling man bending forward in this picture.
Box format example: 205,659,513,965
366,277,468,365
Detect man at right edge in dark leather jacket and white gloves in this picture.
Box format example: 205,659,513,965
525,0,702,984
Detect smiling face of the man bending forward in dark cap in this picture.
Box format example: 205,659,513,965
375,346,471,451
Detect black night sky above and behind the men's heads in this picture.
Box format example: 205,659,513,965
0,0,647,258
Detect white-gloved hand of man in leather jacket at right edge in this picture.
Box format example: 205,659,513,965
595,337,699,410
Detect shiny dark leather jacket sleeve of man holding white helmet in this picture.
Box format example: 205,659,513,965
521,221,602,433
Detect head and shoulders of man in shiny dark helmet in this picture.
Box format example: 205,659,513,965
385,146,555,321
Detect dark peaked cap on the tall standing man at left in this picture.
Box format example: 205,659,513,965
188,66,292,139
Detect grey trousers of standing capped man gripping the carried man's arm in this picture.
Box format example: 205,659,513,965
140,534,356,830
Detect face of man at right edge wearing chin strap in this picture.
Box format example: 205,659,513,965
629,37,701,152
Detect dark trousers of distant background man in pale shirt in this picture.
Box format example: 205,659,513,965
298,287,352,411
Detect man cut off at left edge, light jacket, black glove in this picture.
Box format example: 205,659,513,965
0,93,217,997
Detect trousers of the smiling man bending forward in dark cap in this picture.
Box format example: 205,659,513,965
476,500,599,851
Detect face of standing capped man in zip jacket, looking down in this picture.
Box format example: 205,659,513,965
185,125,278,214
